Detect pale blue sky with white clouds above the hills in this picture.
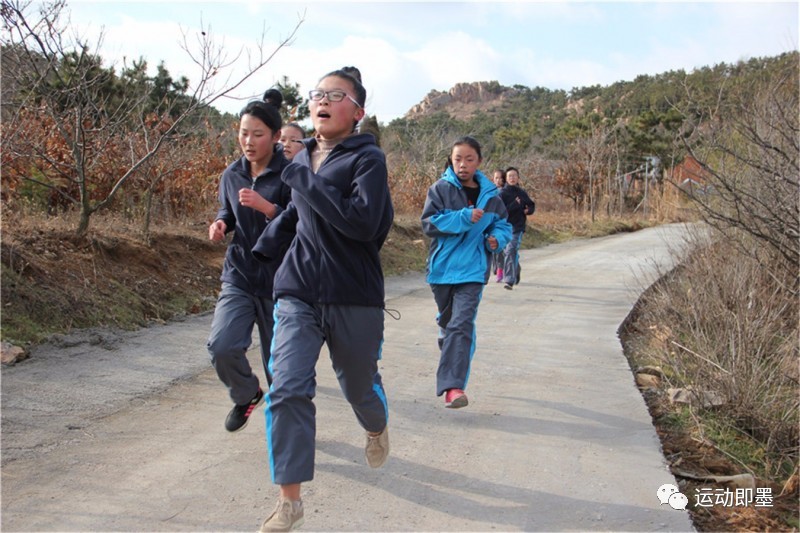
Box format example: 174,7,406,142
67,0,798,123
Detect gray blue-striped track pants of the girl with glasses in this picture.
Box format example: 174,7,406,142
264,297,389,485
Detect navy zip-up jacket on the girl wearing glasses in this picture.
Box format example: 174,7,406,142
253,133,394,307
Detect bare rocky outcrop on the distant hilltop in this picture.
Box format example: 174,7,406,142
406,81,517,118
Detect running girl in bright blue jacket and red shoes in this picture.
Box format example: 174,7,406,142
422,137,511,409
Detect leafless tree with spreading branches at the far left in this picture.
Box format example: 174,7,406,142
0,0,303,235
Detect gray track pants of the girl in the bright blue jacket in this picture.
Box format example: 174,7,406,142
431,283,484,396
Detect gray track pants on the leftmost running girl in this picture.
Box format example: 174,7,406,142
206,283,273,405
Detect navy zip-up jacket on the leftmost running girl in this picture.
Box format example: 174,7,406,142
215,152,291,297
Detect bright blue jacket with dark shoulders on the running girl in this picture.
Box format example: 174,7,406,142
422,167,511,284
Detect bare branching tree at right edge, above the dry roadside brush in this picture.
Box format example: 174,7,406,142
685,52,800,283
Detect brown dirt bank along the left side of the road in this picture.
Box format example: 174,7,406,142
0,212,427,346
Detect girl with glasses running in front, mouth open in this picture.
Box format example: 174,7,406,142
253,67,394,531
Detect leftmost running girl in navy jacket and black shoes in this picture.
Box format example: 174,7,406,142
207,89,289,431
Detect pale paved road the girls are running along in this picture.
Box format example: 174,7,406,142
2,225,692,531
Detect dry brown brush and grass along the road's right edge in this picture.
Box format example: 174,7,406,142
622,225,800,531
